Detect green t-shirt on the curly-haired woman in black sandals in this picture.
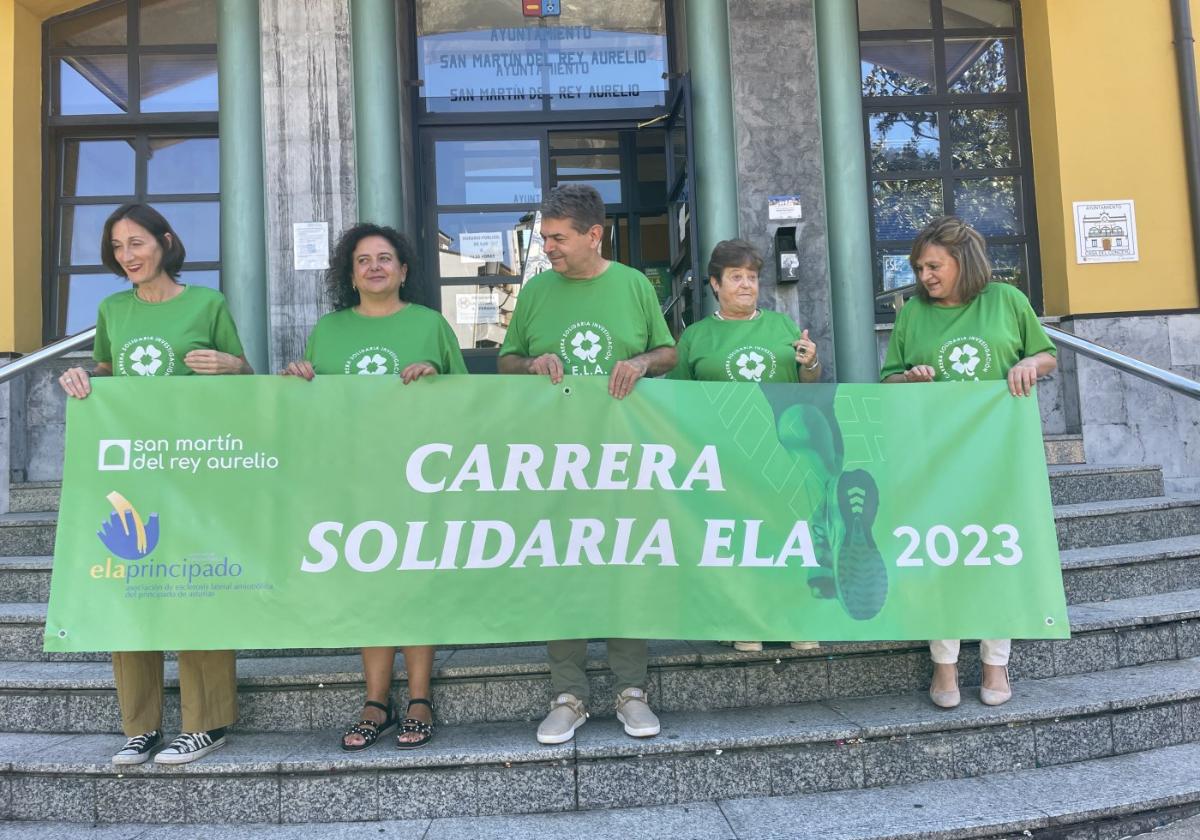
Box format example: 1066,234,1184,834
304,304,467,376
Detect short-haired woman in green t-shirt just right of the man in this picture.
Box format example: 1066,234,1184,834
667,239,821,650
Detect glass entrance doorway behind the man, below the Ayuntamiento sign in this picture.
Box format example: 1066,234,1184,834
420,122,676,373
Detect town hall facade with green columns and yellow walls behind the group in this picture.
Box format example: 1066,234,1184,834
7,0,1200,482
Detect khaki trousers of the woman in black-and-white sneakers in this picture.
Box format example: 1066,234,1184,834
113,650,238,738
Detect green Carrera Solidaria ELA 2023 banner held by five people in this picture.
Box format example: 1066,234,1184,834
46,377,1068,652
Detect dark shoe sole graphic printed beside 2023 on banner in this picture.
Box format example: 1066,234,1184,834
834,469,888,622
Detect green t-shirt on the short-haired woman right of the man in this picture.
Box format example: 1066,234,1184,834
667,310,800,382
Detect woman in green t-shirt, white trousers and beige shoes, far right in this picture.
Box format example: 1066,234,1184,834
881,216,1057,708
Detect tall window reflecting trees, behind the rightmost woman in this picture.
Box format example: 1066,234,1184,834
858,0,1042,308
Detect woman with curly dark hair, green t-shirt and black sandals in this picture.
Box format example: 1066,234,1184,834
283,224,467,752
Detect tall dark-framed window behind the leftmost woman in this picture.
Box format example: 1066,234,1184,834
43,0,221,340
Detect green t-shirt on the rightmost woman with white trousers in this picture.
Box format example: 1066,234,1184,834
880,282,1055,382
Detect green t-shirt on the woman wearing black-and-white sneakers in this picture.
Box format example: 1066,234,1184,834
91,286,245,377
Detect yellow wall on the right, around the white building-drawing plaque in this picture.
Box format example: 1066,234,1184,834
1021,0,1200,314
